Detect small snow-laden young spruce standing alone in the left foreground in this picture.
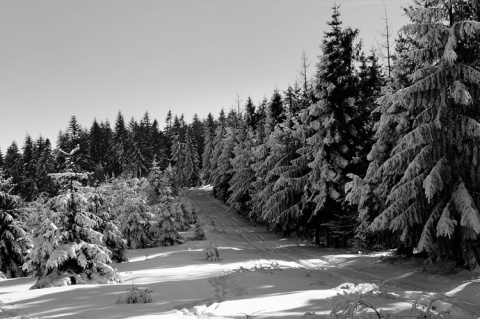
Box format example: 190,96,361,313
23,152,122,289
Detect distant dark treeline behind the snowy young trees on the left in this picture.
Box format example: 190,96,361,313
0,111,215,201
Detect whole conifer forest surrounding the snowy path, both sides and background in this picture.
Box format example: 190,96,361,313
0,0,480,318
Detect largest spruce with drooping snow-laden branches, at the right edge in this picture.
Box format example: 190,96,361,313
350,1,480,267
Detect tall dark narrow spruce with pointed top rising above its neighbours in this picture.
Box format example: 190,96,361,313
305,6,358,245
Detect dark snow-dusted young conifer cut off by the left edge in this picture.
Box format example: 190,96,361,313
0,170,31,278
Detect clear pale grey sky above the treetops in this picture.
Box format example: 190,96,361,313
0,0,410,154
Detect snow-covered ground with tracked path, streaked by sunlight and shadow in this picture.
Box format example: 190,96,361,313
0,188,480,318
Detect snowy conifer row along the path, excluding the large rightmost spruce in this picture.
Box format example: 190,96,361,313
202,7,387,246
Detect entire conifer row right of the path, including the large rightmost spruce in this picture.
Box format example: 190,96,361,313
203,0,480,268
